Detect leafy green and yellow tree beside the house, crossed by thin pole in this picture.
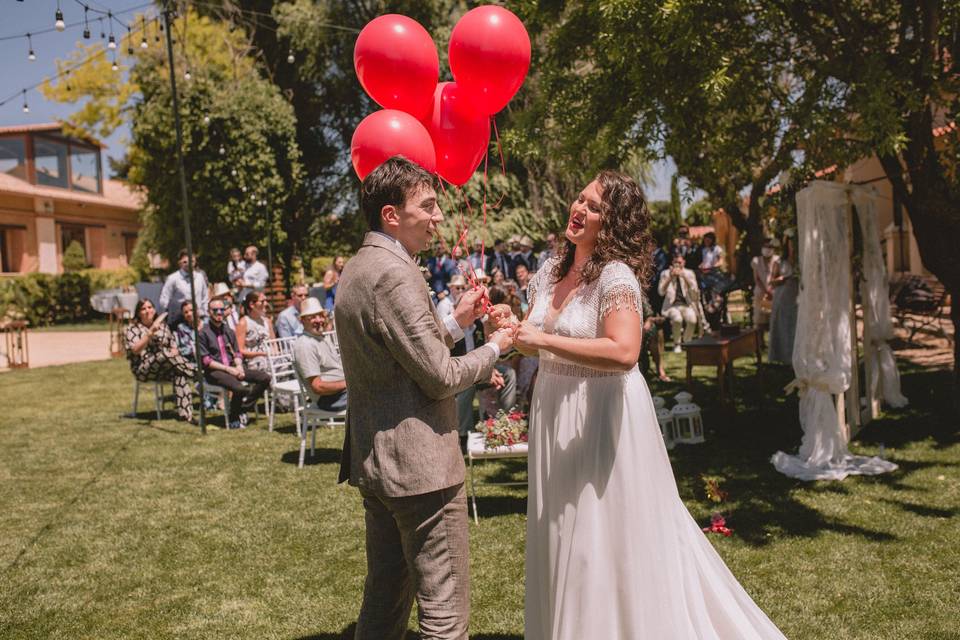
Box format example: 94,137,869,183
47,11,302,273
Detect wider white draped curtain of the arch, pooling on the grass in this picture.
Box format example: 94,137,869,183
771,181,897,480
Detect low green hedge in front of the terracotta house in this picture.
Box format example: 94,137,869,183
0,268,137,327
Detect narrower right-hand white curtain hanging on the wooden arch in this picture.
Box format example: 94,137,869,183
852,188,907,408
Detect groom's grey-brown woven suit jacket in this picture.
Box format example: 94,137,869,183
336,233,495,497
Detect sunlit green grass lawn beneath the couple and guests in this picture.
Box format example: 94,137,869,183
0,354,960,640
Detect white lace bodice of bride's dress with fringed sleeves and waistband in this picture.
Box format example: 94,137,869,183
527,258,642,376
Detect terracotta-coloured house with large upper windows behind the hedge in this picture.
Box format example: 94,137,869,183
0,123,143,276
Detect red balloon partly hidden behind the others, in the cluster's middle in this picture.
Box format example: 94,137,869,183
424,82,490,185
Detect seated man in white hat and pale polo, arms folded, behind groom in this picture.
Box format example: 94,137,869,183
293,298,347,411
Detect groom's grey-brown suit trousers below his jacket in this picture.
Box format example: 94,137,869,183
354,483,470,640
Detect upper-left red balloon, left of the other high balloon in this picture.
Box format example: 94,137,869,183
353,14,440,118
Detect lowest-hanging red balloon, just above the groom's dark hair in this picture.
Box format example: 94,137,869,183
350,109,437,180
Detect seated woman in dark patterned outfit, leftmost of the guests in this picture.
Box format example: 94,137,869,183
124,298,197,422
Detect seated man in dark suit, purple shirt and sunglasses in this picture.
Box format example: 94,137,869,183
197,299,270,429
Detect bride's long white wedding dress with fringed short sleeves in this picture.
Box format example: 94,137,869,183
524,259,784,640
